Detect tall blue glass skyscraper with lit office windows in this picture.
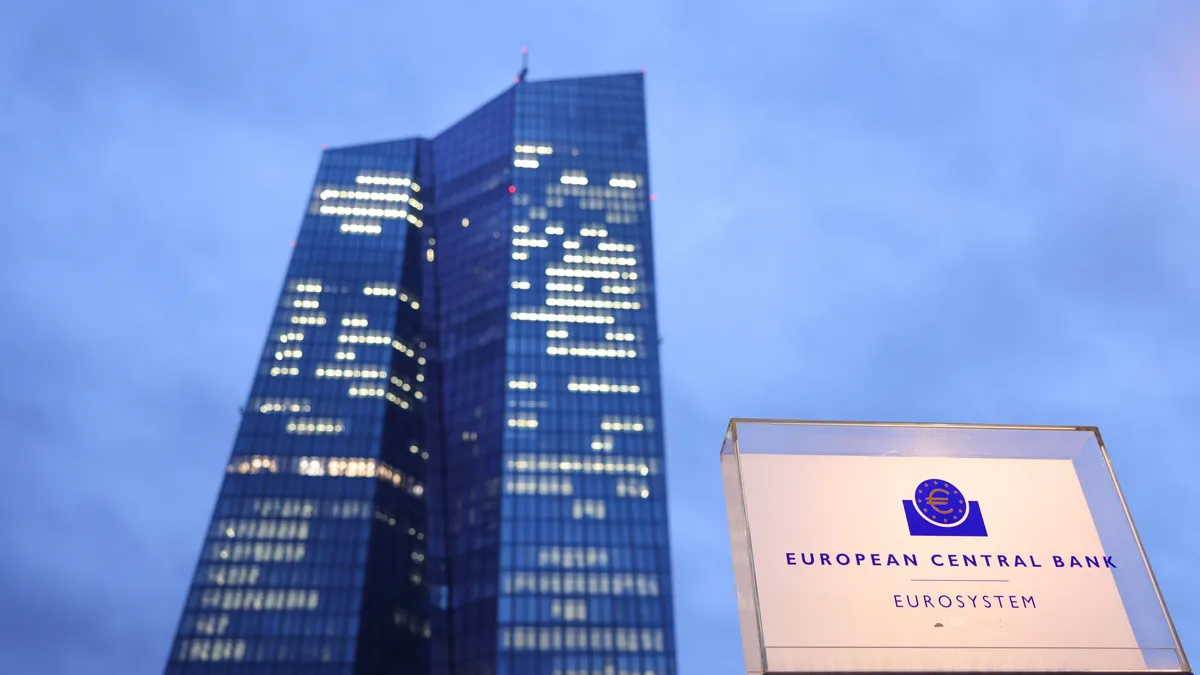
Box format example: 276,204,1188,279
167,73,676,675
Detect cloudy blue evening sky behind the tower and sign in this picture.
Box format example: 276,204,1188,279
0,0,1200,675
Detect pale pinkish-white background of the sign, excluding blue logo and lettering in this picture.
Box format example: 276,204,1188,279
740,454,1146,671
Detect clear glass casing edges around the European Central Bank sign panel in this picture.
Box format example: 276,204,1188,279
721,418,1192,675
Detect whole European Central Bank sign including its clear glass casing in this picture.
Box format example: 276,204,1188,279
722,420,1188,673
